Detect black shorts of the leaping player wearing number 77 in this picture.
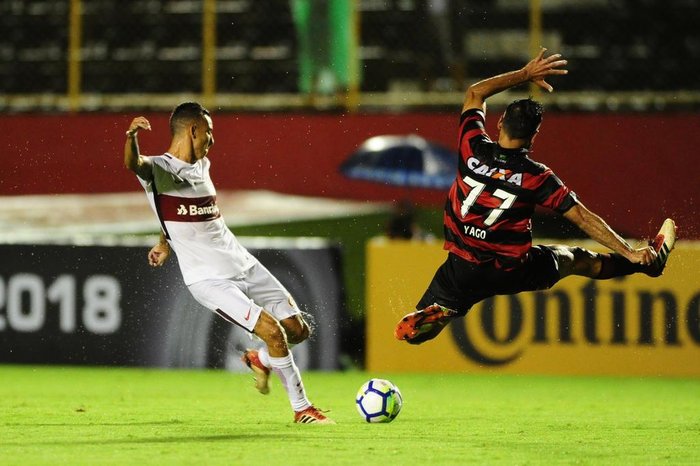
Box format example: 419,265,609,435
416,246,560,315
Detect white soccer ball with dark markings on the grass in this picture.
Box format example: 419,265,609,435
355,379,403,422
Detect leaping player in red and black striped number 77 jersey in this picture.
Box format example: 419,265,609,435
394,48,676,344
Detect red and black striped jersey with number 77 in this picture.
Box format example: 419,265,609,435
444,109,577,269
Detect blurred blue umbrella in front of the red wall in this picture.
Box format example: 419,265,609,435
340,134,457,189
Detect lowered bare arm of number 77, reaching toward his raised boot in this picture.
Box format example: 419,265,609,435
564,202,656,265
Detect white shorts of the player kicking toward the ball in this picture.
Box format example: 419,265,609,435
188,261,300,332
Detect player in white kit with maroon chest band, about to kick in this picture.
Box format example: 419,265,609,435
124,102,333,424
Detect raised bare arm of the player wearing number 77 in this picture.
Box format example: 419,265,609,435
462,47,568,112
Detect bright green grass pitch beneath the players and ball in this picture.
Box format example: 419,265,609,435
0,366,700,466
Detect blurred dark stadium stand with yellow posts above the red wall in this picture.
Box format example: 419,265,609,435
5,0,700,112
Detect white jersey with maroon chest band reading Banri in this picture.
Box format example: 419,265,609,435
137,153,256,285
